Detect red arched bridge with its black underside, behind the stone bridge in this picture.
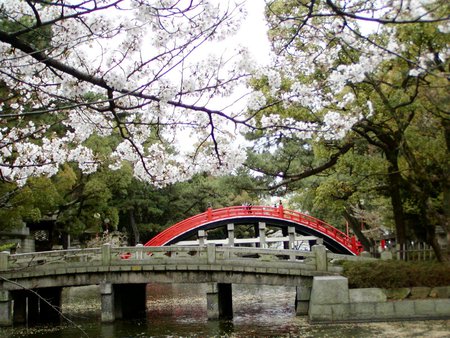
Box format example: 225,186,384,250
145,205,362,255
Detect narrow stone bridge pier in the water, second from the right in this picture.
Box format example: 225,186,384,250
206,283,233,319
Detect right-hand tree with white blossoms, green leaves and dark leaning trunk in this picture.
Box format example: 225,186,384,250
246,0,450,257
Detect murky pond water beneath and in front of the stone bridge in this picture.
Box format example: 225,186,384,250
0,284,450,338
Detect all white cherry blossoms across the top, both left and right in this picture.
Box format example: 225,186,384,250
0,0,449,185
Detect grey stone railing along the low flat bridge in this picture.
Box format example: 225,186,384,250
0,244,370,277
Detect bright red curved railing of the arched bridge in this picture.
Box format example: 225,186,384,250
144,206,362,255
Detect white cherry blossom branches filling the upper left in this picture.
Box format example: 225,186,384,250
0,0,250,185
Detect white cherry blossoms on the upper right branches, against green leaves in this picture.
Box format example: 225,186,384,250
254,0,450,140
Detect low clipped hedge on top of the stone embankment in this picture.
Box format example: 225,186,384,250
343,260,450,289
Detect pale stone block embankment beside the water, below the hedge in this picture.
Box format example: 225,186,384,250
308,276,450,322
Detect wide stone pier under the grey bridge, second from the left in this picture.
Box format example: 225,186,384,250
100,283,146,323
